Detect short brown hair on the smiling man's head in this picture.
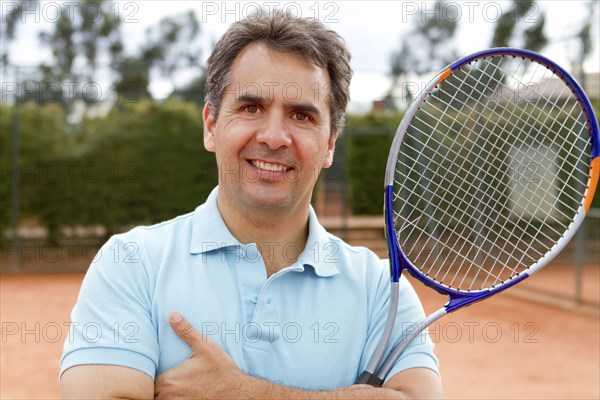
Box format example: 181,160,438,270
206,10,352,132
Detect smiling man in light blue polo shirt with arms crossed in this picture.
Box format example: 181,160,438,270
61,12,442,399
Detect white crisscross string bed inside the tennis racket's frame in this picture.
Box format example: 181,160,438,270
394,54,588,290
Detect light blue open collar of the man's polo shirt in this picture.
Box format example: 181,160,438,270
190,187,341,277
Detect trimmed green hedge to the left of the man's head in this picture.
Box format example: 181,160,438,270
0,102,217,240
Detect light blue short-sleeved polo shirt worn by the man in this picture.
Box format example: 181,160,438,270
61,189,438,390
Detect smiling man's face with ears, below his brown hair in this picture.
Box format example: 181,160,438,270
204,43,337,212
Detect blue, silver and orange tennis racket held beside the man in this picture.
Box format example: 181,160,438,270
357,48,600,386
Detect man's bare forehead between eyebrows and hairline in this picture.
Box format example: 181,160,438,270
225,43,330,105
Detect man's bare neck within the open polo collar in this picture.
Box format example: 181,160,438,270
217,192,309,276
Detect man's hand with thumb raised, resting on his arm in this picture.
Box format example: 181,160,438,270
154,312,250,399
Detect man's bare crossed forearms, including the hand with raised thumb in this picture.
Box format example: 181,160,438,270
61,313,443,400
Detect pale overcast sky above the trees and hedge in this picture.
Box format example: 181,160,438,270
0,0,600,111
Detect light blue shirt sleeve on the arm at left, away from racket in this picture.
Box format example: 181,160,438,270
60,233,159,379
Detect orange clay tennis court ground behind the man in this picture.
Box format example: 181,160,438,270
0,264,600,399
